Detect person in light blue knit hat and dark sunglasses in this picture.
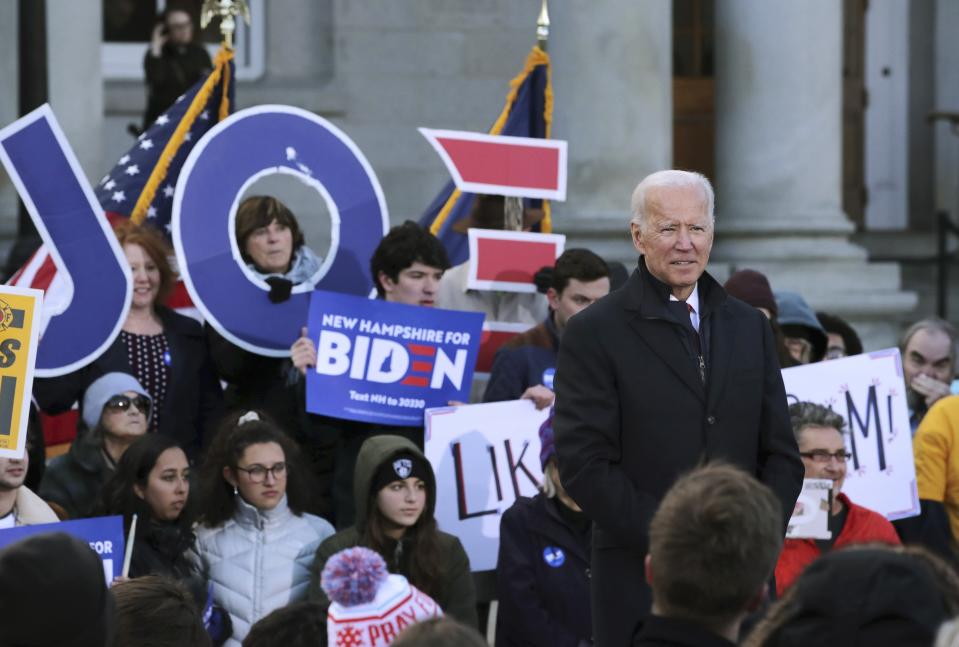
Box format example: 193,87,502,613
39,373,153,519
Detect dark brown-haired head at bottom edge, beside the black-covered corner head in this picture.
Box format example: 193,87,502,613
112,575,210,647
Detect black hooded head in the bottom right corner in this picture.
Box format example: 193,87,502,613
744,546,959,647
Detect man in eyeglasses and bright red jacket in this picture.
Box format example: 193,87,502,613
776,402,900,595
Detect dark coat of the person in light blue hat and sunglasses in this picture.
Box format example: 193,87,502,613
37,432,113,519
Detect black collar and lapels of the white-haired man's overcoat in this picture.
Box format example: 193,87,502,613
623,256,731,403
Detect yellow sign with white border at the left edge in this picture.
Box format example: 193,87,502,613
0,285,43,458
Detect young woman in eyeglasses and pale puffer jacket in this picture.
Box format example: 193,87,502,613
196,411,333,647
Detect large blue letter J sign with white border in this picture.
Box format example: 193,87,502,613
0,105,132,377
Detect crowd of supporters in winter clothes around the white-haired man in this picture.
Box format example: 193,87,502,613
0,191,959,647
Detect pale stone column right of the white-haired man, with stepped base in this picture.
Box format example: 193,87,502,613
713,0,916,349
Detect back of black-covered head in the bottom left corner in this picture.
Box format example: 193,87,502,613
0,533,116,647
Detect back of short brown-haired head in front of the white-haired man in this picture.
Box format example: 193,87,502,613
649,465,783,626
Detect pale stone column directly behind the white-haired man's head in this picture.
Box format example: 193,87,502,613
549,0,673,266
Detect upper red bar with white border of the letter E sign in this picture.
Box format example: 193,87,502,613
419,128,567,201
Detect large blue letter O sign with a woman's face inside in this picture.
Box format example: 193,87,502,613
173,105,389,357
